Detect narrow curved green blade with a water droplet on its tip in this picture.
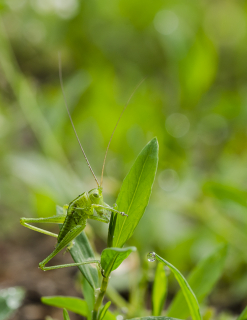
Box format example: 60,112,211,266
148,252,202,320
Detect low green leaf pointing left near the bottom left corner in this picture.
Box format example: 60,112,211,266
41,296,88,317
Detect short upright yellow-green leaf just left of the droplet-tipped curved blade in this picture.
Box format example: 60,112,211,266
152,262,167,316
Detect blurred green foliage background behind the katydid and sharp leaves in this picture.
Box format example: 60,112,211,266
0,0,247,313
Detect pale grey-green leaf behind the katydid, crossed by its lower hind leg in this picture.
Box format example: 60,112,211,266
57,206,99,289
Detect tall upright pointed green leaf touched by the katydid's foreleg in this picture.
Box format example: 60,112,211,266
108,138,158,248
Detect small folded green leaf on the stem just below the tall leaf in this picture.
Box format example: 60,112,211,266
101,247,136,277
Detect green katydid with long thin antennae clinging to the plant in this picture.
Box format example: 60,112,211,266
20,59,144,271
